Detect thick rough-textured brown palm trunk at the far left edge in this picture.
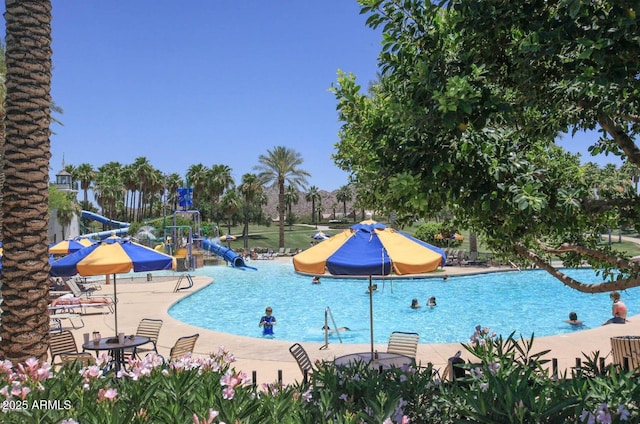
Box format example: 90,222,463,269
0,0,51,362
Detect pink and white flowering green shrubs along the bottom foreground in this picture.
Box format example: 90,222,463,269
0,327,640,424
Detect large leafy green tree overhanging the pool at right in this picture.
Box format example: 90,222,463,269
333,0,640,292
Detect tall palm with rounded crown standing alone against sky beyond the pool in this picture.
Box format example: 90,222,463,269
254,146,310,247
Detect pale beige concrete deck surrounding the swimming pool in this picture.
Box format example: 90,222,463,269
63,258,640,384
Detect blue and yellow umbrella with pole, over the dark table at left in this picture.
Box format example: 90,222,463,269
50,237,176,335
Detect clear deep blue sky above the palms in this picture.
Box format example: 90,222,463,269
2,0,624,191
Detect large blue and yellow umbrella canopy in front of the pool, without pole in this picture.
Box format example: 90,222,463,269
293,220,446,275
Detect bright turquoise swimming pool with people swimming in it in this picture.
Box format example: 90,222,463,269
169,261,640,344
